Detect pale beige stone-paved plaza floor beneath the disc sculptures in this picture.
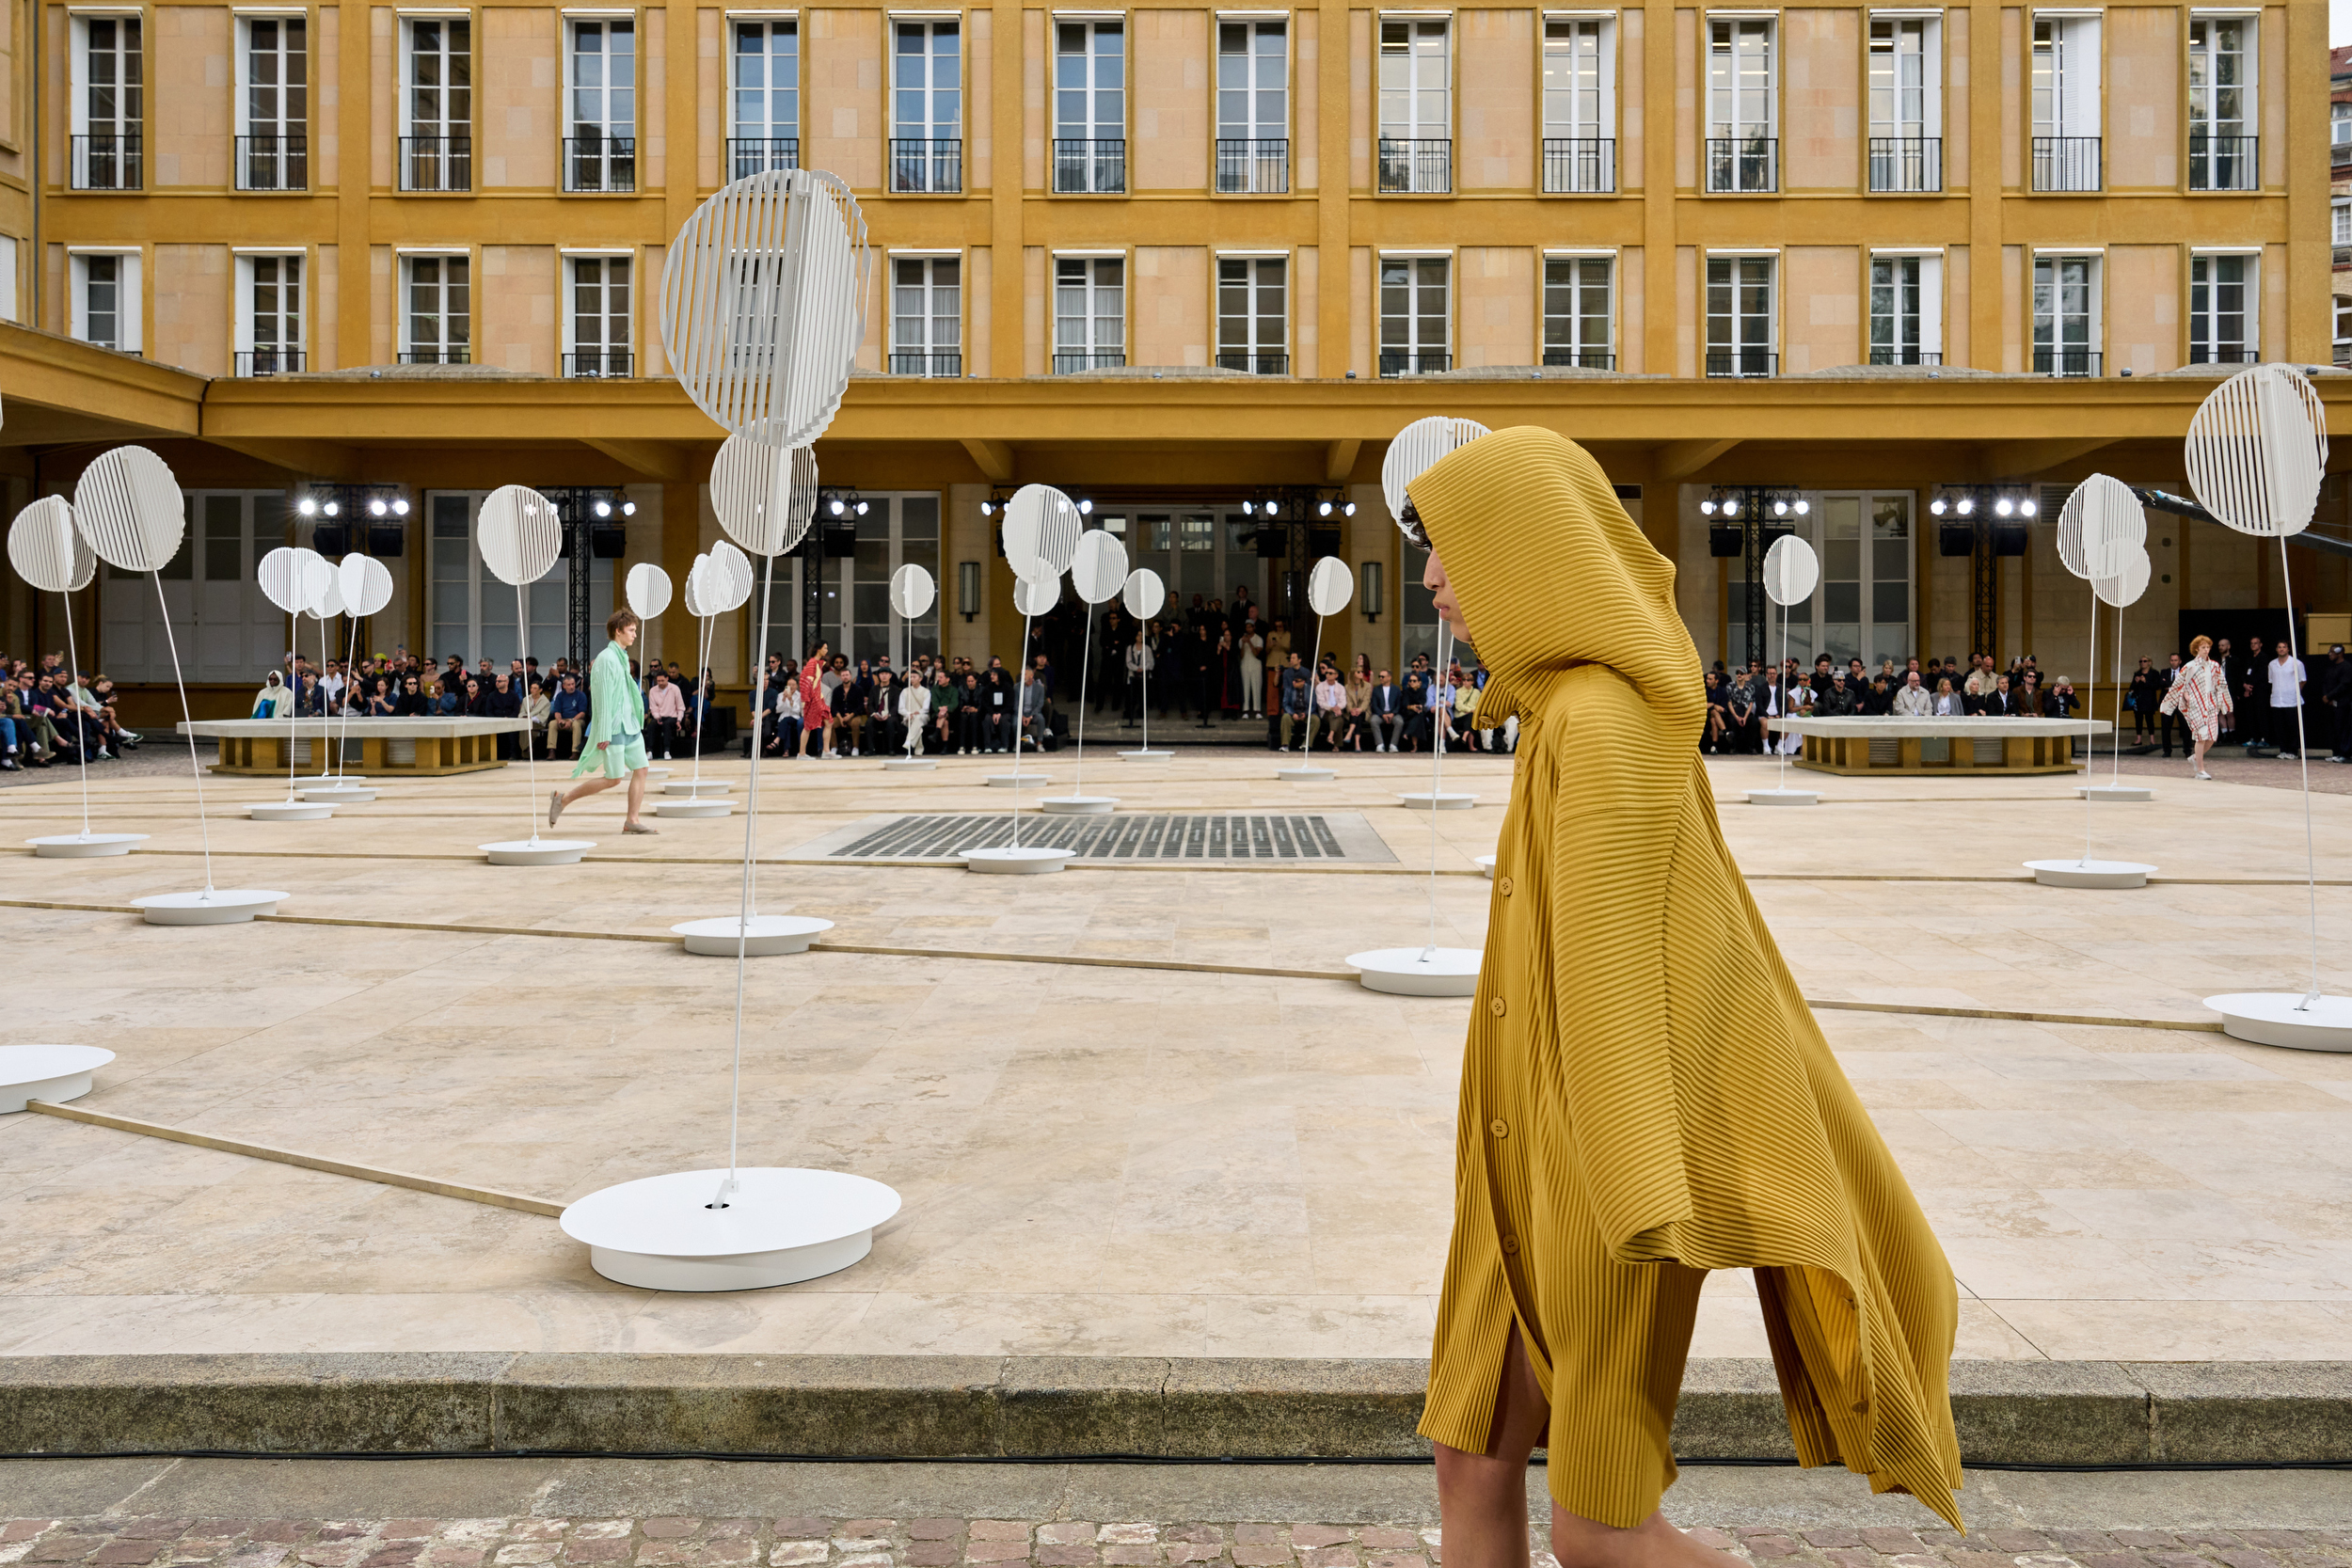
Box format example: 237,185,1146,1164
0,752,2352,1363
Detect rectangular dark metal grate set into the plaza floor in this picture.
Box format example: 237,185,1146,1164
821,811,1397,861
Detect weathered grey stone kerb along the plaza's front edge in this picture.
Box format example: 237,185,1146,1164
0,1352,2352,1467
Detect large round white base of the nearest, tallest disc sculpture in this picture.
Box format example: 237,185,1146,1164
558,1166,898,1291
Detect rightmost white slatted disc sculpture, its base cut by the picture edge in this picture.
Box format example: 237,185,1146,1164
2187,364,2352,1051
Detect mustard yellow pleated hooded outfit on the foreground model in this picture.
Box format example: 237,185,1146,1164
1411,428,1960,1528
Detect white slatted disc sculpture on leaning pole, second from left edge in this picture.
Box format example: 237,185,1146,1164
73,447,285,927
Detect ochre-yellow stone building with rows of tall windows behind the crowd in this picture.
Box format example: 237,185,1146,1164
0,0,2347,710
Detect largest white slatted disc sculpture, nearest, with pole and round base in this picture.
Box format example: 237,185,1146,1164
563,169,898,1291
